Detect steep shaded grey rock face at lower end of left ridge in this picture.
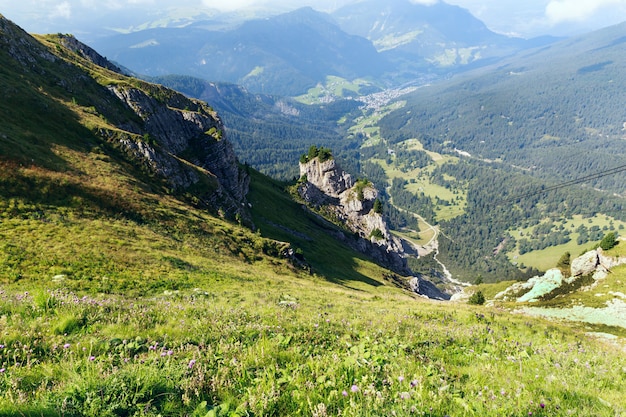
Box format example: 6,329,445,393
109,85,249,217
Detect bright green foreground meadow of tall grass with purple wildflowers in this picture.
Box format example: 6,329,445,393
0,281,626,416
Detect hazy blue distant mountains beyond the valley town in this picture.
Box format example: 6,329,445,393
93,0,554,96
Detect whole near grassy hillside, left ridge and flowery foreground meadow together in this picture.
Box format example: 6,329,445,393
0,18,626,417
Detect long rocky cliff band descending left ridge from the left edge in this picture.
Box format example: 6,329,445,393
0,15,249,219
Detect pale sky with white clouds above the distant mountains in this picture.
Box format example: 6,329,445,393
0,0,626,38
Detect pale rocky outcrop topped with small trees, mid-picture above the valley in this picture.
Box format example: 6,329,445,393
298,158,410,274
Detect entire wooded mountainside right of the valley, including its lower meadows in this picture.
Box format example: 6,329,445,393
366,24,626,279
